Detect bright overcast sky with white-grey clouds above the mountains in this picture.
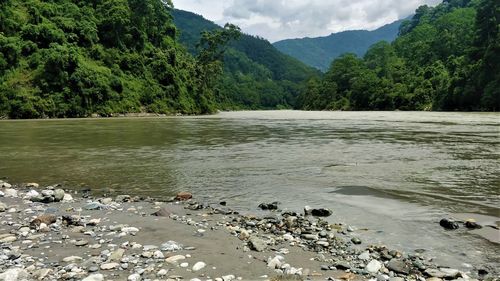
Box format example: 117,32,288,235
174,0,442,42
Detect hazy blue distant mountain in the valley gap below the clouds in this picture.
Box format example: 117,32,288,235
273,20,404,71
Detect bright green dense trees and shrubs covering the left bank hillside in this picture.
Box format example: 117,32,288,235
0,0,239,118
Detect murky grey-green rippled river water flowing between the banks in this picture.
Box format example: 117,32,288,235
0,111,500,269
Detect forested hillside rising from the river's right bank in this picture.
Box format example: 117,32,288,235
298,0,500,111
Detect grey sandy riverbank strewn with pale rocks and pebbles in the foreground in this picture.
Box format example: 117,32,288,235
0,181,498,281
